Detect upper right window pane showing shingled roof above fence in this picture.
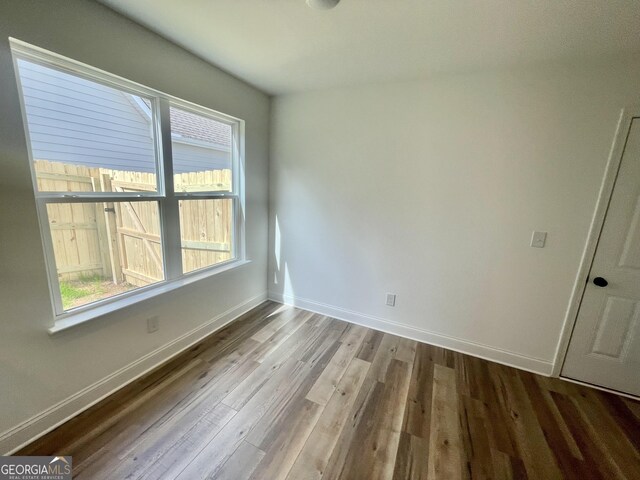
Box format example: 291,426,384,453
171,107,232,192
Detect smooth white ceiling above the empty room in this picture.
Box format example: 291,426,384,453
100,0,640,94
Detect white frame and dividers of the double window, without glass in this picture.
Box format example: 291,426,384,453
9,38,249,333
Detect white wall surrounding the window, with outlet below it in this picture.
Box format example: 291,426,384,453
0,0,269,453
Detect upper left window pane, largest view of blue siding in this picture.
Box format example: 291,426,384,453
18,59,157,192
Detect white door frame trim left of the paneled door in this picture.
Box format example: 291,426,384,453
551,104,640,378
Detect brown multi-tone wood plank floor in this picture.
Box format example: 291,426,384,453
19,302,640,480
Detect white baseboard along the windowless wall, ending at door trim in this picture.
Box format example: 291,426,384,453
269,292,553,376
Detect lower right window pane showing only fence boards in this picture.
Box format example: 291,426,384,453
179,198,235,273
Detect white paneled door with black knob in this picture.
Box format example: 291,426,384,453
562,118,640,396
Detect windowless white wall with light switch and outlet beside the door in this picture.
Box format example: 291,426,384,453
269,57,640,373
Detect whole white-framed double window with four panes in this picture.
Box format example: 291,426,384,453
11,39,244,326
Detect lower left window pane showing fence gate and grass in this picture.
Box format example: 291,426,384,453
47,202,164,311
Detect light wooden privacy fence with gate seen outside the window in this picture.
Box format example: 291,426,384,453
35,160,233,286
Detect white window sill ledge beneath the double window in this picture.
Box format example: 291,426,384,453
48,260,251,335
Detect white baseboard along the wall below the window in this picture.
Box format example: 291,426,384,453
0,292,267,455
